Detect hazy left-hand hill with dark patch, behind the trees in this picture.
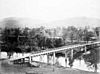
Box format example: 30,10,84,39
0,17,44,28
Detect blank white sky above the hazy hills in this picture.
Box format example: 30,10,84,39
0,0,100,22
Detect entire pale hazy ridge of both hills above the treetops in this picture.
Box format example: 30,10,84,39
0,17,100,28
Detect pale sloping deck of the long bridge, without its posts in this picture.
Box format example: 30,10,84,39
9,42,100,61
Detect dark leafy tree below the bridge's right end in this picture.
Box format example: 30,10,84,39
83,48,100,72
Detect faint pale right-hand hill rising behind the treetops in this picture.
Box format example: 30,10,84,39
43,17,100,27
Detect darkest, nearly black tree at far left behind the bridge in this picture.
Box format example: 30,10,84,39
1,28,20,58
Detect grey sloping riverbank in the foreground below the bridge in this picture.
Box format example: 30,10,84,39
0,60,99,74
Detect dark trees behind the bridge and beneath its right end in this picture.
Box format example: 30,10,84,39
0,26,100,71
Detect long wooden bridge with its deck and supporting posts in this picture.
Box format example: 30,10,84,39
9,41,100,66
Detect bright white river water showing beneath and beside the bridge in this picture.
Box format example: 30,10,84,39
0,52,100,72
